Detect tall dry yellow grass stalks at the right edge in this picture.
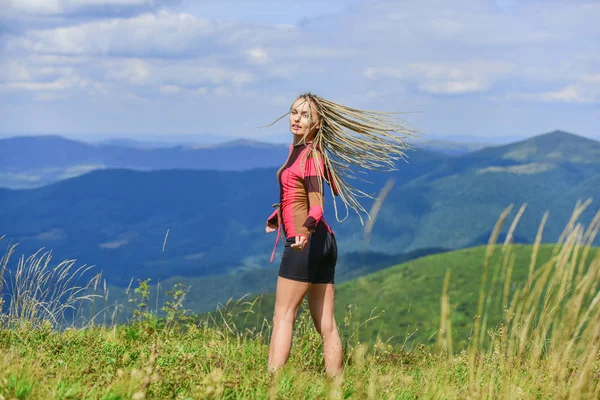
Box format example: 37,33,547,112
438,200,600,399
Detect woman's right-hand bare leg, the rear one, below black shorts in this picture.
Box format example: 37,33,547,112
308,283,342,376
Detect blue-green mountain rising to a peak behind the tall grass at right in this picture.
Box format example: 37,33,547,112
371,131,600,251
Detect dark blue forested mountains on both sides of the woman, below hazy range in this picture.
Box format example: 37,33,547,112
0,132,600,298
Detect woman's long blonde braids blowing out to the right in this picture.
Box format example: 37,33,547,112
267,92,418,224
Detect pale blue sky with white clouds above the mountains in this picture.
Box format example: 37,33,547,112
0,0,600,144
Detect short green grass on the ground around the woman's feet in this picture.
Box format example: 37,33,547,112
0,310,596,399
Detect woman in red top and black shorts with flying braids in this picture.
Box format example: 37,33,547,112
265,93,414,376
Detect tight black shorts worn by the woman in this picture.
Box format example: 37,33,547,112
279,224,337,283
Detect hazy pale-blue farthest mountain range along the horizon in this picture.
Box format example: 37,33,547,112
0,135,486,189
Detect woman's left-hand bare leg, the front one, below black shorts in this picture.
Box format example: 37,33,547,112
268,276,310,371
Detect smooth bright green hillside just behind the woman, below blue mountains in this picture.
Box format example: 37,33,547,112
225,244,598,348
